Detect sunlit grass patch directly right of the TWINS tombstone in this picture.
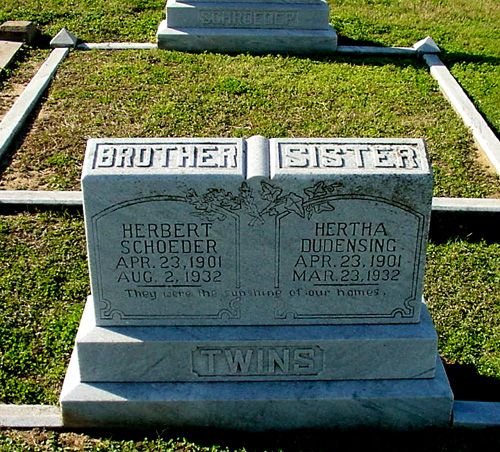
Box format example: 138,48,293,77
424,240,500,379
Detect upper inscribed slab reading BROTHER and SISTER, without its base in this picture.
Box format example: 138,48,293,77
83,138,432,325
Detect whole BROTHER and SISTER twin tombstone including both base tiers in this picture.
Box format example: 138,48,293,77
61,136,453,430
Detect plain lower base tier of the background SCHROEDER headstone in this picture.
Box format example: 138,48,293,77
157,20,337,55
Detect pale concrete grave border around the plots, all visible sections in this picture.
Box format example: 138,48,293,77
0,30,500,429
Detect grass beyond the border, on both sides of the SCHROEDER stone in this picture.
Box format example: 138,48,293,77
0,0,500,136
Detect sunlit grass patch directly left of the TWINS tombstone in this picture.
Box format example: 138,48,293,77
0,213,89,404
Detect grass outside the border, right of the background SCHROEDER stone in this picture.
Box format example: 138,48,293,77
330,0,500,134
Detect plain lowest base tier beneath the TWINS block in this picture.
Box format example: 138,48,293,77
61,354,453,431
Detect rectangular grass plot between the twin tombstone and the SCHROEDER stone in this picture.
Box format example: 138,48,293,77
0,51,500,197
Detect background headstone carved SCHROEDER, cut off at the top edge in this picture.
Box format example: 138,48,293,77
157,0,337,54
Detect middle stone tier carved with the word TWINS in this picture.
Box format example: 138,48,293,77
76,298,437,382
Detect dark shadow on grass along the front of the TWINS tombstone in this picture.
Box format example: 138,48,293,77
62,428,500,452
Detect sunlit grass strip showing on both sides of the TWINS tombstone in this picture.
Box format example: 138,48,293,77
0,212,500,404
